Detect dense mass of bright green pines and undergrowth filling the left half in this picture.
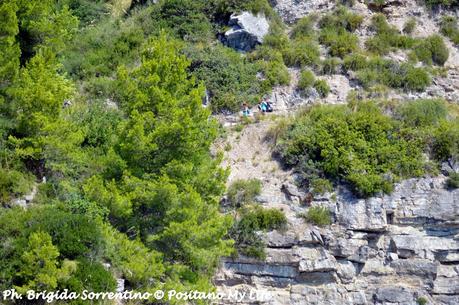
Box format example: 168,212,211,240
0,0,287,291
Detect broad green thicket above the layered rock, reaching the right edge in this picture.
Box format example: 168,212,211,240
277,100,459,197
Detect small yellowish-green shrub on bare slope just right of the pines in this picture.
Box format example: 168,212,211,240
228,179,261,207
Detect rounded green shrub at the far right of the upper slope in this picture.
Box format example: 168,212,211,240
414,35,449,66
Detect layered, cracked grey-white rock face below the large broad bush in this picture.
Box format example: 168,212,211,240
215,176,459,305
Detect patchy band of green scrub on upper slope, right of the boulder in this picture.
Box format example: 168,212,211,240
290,6,440,93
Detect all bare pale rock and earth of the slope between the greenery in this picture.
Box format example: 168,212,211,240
214,0,459,305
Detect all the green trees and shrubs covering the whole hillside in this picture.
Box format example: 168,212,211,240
0,0,459,298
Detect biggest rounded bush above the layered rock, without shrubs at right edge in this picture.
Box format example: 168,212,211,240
276,102,424,197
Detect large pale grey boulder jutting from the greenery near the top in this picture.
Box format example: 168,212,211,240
224,12,269,51
